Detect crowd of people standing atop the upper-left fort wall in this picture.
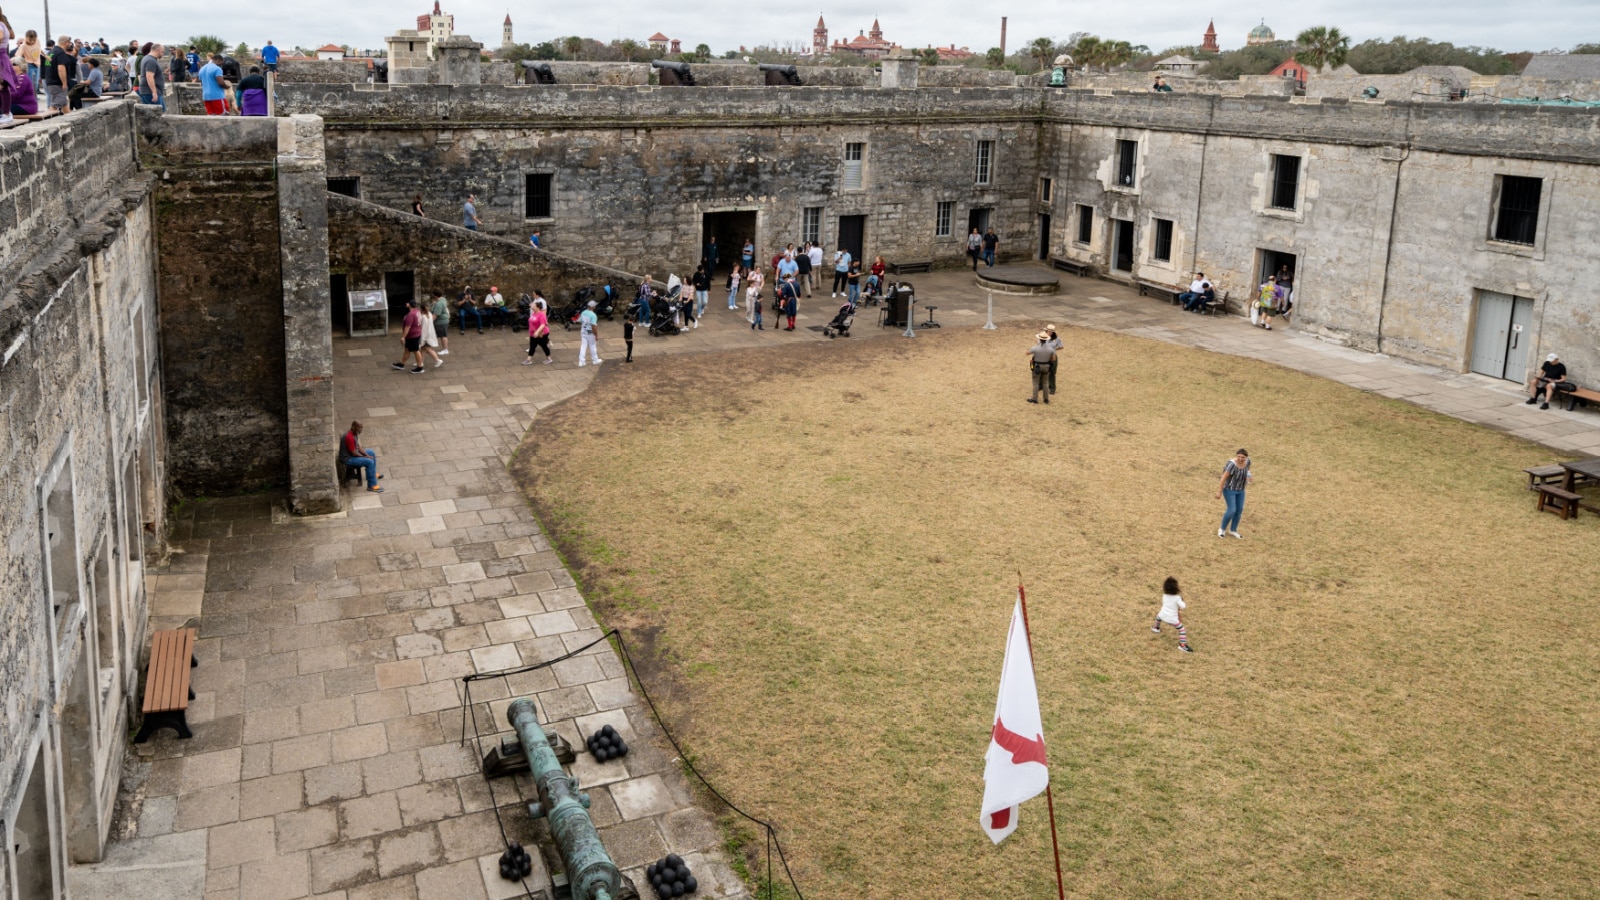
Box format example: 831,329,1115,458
0,25,278,125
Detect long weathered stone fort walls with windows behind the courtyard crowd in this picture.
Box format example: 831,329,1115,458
268,85,1600,380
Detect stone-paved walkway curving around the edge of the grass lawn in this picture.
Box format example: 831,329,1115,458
87,261,1600,900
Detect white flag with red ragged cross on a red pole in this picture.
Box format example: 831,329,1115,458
979,594,1050,844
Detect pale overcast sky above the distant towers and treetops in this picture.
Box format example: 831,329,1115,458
18,0,1600,53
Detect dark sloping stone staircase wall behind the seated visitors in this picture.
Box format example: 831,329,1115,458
328,194,646,306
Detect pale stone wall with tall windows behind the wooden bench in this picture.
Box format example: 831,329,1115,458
0,104,166,877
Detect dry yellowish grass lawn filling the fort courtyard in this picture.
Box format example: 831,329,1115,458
515,328,1600,898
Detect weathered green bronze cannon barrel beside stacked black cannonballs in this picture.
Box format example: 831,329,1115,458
506,697,622,900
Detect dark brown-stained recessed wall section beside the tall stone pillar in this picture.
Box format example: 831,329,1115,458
139,110,290,496
